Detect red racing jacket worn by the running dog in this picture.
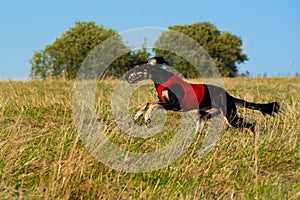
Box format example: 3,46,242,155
156,75,204,111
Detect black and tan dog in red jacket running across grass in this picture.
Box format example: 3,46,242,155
125,57,280,132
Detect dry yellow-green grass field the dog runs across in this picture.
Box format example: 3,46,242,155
0,78,300,199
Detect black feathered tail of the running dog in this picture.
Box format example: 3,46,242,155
233,97,280,115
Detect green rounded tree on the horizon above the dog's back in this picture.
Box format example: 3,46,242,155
154,22,248,78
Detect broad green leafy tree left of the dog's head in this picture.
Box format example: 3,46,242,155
30,22,149,80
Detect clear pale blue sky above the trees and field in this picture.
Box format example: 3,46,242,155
0,0,300,80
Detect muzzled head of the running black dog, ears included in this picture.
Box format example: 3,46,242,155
125,57,169,84
